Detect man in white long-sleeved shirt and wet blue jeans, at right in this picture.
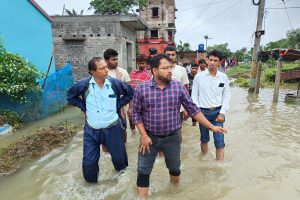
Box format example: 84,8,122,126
192,50,230,160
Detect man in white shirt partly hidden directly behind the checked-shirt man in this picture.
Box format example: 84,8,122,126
164,46,189,120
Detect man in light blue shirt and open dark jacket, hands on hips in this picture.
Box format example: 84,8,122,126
67,57,134,183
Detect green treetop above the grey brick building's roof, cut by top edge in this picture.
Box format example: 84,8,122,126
90,0,147,15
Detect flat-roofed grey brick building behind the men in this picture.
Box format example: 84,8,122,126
52,16,136,80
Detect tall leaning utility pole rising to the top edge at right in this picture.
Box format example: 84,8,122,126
249,0,265,93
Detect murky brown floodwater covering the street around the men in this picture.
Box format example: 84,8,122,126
0,88,300,200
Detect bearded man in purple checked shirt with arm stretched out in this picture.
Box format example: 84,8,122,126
133,55,226,197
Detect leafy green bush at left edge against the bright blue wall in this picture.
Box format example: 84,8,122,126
0,41,42,102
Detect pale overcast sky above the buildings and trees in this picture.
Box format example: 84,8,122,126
35,0,300,51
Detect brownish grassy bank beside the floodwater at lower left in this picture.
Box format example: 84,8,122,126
0,124,77,176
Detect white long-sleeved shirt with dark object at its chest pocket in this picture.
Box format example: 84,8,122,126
192,70,230,114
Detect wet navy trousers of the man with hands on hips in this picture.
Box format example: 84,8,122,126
82,120,128,182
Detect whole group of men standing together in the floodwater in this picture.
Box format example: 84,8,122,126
67,47,230,197
